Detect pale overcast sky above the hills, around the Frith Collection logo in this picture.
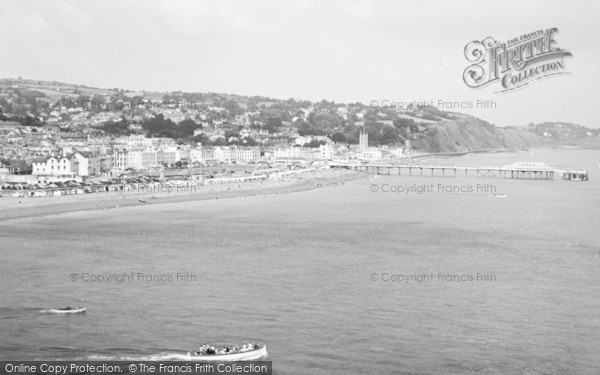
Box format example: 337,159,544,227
0,0,600,128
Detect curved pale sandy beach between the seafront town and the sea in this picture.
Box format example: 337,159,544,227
0,170,368,222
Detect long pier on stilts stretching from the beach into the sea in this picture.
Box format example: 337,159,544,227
329,163,556,180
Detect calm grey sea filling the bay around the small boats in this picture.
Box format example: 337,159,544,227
0,149,600,374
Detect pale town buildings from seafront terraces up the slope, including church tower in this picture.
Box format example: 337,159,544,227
0,80,409,183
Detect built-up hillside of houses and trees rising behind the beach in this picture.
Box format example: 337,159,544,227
0,80,432,188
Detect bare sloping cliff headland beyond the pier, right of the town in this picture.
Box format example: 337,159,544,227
410,116,544,153
